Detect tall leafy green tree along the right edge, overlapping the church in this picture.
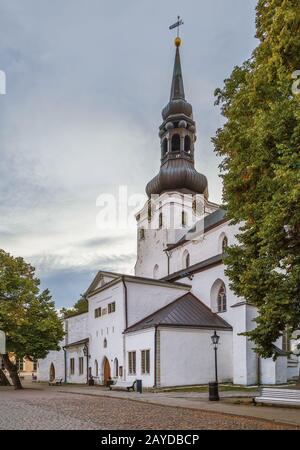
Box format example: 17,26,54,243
213,0,300,358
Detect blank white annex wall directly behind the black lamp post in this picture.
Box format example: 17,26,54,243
160,327,233,386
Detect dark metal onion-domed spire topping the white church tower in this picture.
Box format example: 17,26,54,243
146,34,208,198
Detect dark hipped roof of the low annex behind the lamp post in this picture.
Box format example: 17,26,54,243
125,293,232,333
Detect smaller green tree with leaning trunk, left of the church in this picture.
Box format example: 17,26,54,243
0,250,64,389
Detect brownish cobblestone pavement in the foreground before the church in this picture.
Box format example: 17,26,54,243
0,389,293,430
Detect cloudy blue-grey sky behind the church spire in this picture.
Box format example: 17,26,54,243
0,0,256,308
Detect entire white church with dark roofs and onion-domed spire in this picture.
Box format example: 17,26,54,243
38,38,299,387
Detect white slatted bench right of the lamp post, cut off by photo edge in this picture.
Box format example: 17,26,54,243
253,388,300,406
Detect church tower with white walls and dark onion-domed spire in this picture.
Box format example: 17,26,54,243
135,36,216,278
